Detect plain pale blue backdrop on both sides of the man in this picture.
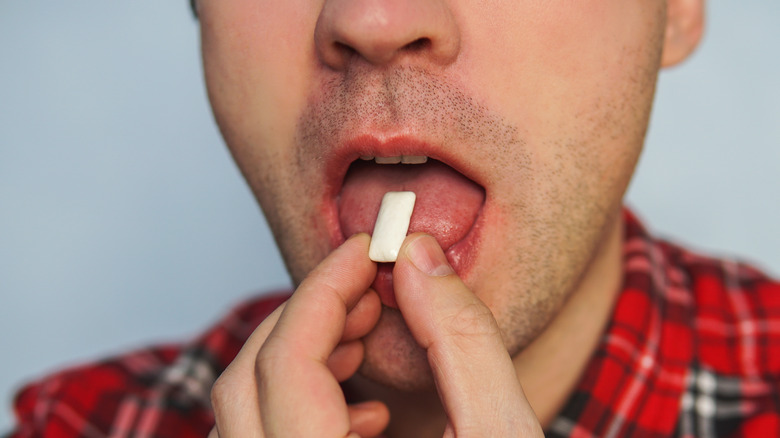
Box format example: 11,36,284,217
0,0,780,430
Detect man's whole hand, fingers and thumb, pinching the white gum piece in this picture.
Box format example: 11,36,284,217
210,234,543,438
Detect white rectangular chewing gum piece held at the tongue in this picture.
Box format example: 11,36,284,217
368,192,417,262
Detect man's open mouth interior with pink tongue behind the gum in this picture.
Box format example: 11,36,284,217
336,155,485,308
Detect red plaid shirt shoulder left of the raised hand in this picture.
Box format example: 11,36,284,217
10,294,286,438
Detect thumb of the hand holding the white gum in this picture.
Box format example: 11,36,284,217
393,233,544,437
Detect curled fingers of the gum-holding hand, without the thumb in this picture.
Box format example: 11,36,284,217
209,234,389,438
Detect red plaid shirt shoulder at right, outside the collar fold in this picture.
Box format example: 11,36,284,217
662,243,780,437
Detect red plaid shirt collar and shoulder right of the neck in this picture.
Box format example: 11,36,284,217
549,212,780,438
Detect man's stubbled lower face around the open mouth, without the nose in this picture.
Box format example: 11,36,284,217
203,2,662,389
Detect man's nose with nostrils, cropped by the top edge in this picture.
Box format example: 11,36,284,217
314,0,460,70
